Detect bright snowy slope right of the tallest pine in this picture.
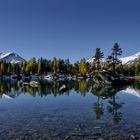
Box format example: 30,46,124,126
120,52,140,64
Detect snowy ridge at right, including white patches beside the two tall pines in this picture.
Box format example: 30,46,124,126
87,52,140,64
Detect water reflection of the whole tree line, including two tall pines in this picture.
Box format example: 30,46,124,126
0,80,140,124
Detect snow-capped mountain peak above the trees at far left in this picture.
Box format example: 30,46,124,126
0,52,24,63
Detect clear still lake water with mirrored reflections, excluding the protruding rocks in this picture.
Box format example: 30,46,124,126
0,80,140,140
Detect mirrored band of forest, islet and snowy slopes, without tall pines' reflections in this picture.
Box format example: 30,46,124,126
0,80,140,98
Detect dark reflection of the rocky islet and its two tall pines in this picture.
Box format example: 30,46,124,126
92,87,125,124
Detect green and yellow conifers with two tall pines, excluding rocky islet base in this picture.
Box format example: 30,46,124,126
0,43,140,77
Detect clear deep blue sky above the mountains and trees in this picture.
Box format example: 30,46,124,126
0,0,140,62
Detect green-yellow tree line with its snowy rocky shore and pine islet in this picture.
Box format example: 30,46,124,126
0,43,140,83
